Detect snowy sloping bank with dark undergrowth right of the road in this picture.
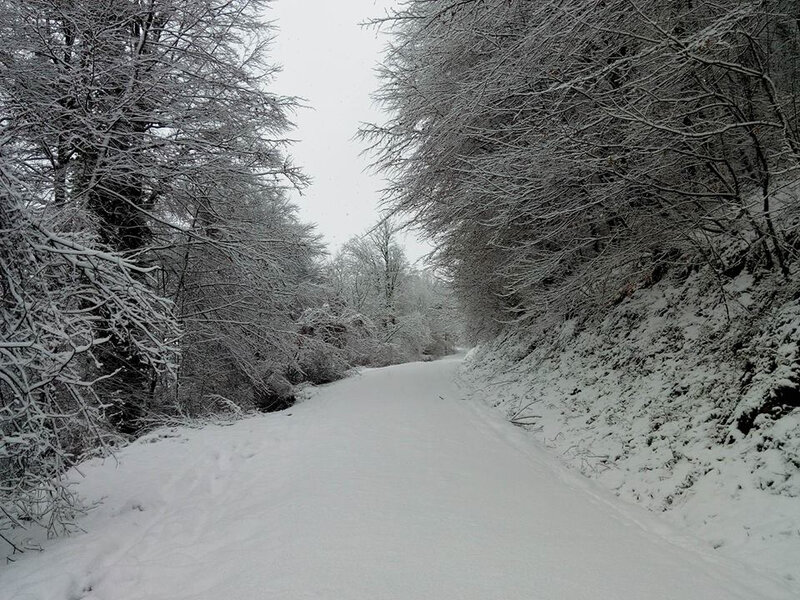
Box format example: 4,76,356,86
465,271,800,597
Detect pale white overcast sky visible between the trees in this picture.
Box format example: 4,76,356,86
267,0,430,261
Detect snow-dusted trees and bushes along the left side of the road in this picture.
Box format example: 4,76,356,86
0,0,457,544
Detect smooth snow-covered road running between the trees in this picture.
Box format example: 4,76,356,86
0,359,791,600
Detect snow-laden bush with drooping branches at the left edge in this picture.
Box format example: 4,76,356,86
0,198,178,548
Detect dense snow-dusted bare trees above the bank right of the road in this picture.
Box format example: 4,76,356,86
363,0,800,338
